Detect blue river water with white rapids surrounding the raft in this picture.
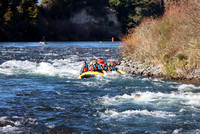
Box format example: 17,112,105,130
0,42,200,134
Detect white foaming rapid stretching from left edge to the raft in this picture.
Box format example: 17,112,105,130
0,59,81,77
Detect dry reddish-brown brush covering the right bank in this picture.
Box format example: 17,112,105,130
122,0,200,78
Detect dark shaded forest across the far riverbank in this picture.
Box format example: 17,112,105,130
0,0,164,41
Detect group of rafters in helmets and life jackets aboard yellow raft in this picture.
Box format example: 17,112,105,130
80,57,117,74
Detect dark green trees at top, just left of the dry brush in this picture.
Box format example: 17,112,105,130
109,0,164,32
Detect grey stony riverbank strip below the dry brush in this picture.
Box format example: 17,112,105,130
117,58,200,84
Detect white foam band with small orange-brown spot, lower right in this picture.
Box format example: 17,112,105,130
100,91,200,108
